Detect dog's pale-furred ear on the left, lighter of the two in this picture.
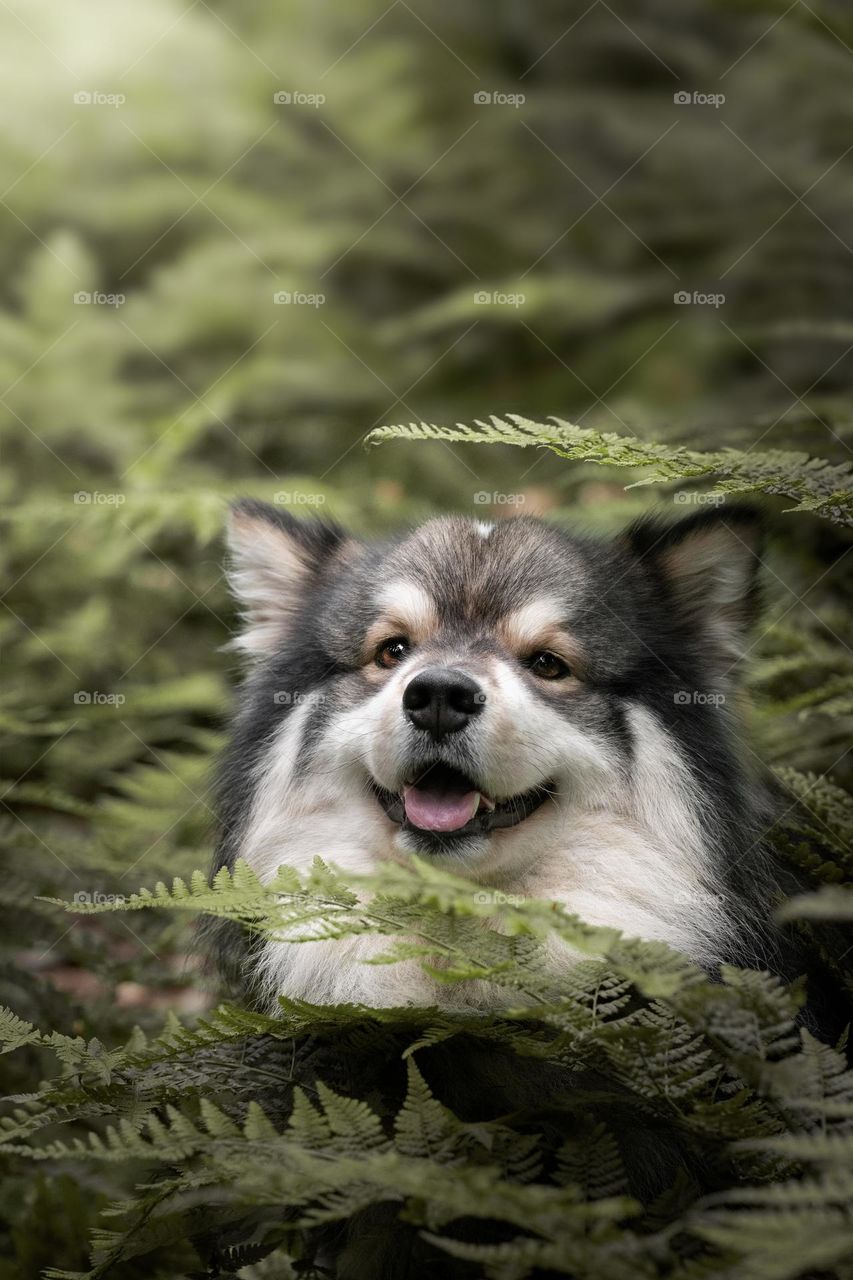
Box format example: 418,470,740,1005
228,498,355,659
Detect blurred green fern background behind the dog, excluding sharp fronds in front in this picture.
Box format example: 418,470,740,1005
0,0,853,1276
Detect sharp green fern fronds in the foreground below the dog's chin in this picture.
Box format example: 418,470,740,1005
0,861,853,1280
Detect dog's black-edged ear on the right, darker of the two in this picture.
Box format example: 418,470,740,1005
628,503,763,668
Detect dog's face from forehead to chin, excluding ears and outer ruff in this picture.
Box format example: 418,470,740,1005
311,520,621,861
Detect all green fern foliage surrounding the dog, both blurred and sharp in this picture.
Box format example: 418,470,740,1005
0,0,853,1280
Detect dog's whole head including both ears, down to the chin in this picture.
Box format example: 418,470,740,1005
224,502,757,896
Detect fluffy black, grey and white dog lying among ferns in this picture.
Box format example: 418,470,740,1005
215,499,777,1009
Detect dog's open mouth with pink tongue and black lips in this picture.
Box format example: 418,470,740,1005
374,763,553,837
